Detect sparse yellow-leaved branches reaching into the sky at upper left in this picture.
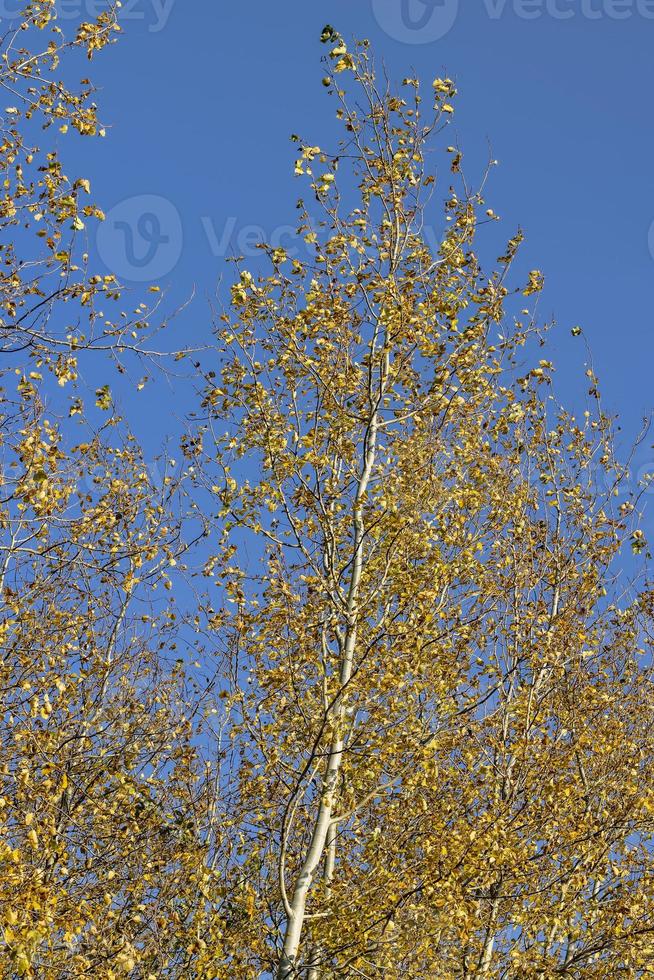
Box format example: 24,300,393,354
0,0,172,386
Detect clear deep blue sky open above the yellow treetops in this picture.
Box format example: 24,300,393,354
61,0,654,527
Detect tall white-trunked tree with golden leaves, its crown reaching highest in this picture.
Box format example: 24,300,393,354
197,27,654,980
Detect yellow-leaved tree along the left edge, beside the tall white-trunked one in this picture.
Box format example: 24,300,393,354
0,0,231,980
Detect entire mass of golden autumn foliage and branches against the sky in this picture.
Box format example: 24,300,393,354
0,3,654,980
